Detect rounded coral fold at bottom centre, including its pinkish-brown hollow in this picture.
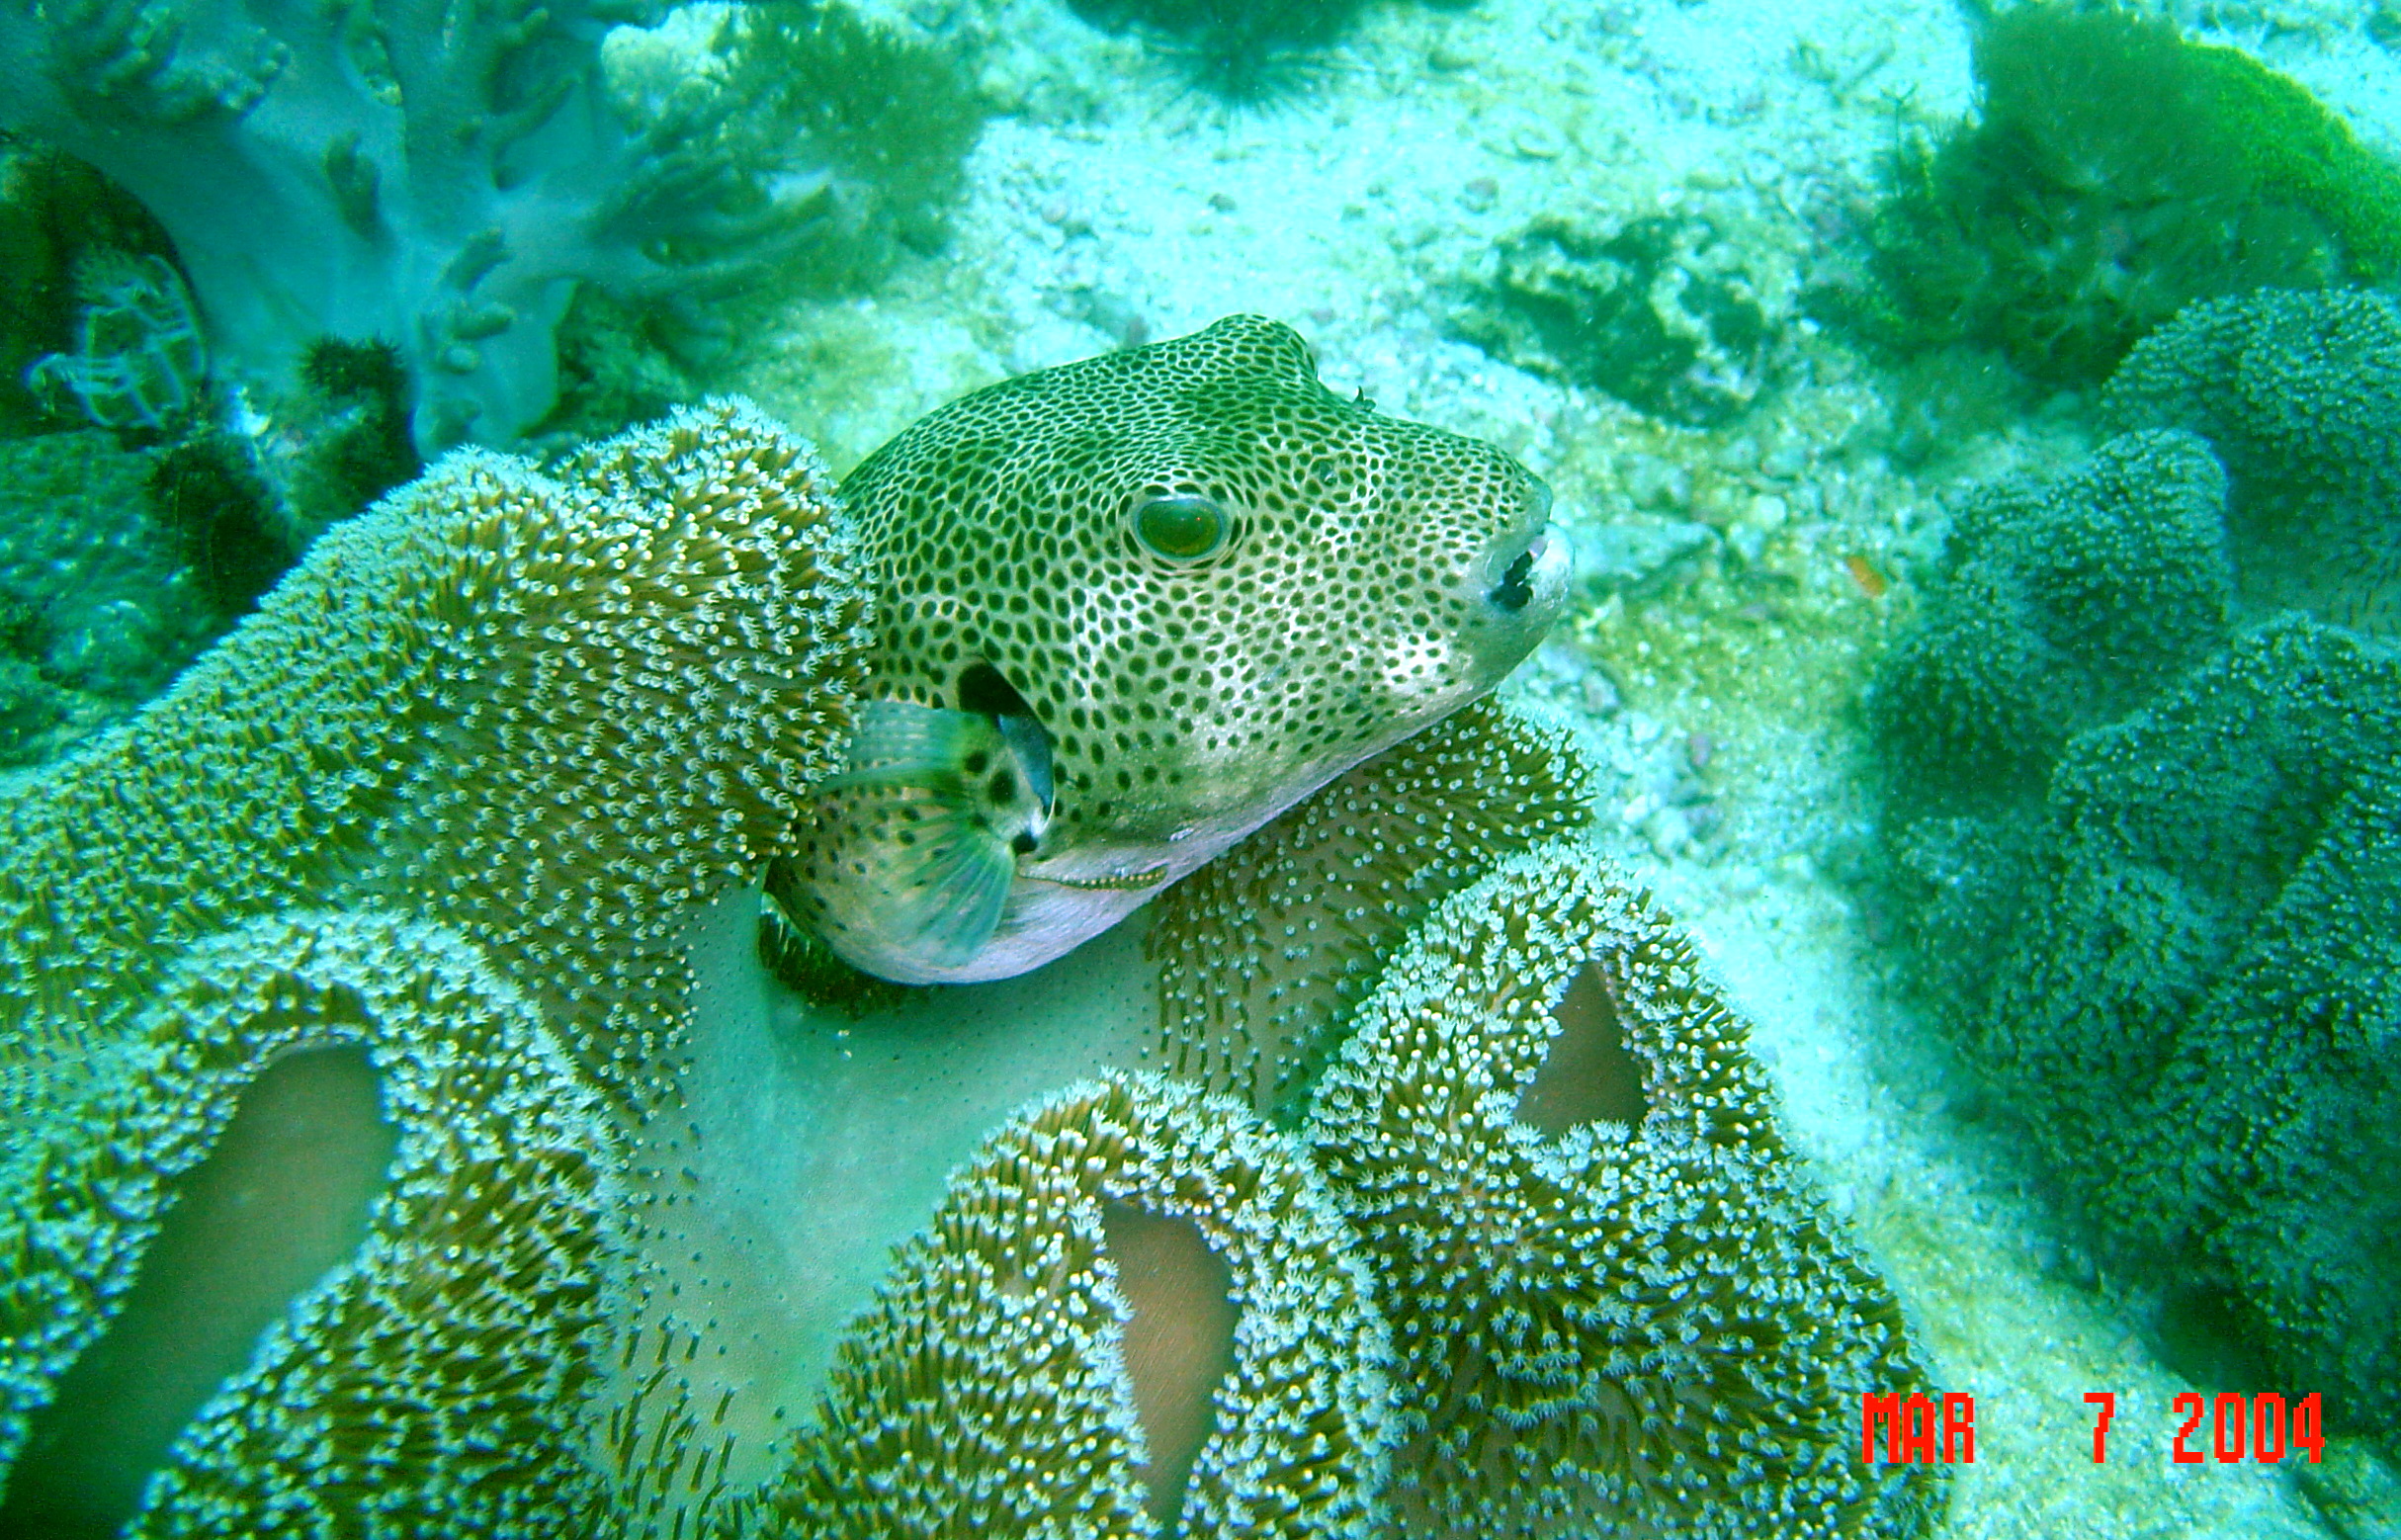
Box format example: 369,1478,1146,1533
743,1076,1393,1540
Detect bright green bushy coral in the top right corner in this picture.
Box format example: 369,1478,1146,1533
1815,5,2401,385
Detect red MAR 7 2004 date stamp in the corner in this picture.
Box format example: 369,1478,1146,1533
1858,1391,2327,1466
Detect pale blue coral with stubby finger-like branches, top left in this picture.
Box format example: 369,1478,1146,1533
0,0,984,452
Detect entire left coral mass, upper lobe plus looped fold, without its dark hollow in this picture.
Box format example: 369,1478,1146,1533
0,401,864,1535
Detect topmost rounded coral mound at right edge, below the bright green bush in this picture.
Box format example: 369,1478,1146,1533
2101,291,2401,635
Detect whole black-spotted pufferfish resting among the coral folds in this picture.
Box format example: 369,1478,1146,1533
768,314,1571,983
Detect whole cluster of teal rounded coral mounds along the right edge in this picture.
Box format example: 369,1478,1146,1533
1870,355,2401,1436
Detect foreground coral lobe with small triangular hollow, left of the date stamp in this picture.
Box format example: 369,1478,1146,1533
1306,841,1942,1538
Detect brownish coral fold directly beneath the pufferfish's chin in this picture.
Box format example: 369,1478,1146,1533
1146,699,1594,1112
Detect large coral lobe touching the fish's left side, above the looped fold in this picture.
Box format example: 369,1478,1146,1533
0,403,862,1105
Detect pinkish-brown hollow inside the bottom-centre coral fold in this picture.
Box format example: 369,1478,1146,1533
1102,1204,1242,1530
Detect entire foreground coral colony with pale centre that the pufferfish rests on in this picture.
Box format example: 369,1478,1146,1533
0,331,1930,1538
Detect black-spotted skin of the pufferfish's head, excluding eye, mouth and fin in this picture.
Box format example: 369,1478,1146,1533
843,317,1541,843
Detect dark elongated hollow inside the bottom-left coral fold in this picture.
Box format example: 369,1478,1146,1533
0,1048,398,1540
